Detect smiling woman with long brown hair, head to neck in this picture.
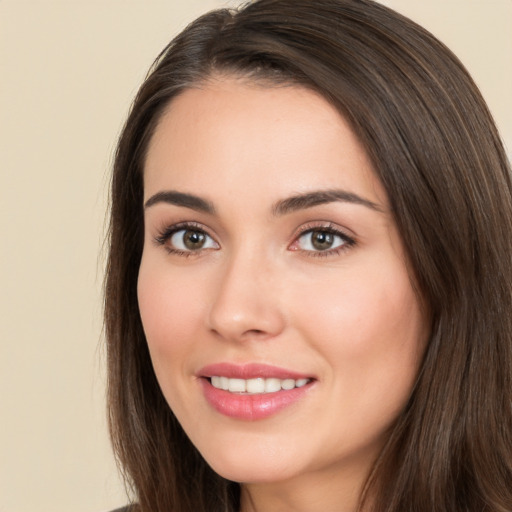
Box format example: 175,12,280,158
106,0,512,512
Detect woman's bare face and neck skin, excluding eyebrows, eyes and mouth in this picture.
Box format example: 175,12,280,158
138,77,426,512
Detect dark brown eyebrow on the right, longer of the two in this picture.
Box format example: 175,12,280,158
272,189,384,216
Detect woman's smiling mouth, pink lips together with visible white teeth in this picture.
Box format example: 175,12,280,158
198,363,315,421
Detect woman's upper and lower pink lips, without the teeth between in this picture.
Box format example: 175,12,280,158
198,363,314,421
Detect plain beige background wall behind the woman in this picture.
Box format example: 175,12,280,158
0,0,512,512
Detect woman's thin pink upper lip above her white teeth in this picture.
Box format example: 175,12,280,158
197,363,313,380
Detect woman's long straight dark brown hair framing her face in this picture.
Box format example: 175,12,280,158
105,0,512,512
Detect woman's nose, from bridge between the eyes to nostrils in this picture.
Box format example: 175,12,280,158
208,249,285,341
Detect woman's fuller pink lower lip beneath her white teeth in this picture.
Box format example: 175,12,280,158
201,379,312,421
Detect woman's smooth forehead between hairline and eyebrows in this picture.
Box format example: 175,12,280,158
144,78,385,208
